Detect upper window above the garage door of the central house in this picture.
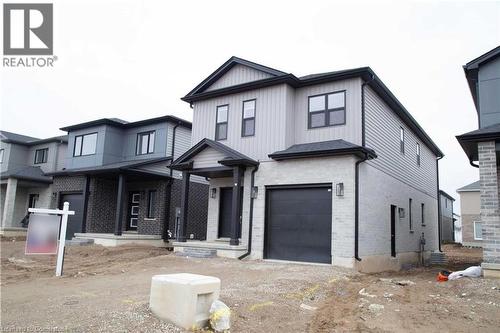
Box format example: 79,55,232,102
308,91,345,128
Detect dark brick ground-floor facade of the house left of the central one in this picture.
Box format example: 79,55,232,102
51,176,208,239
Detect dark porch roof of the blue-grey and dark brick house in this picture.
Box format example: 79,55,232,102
48,156,172,178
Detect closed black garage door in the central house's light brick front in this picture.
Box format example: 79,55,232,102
265,185,332,263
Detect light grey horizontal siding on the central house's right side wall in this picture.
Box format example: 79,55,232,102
365,87,437,198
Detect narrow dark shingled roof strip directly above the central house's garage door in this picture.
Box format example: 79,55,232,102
269,140,377,161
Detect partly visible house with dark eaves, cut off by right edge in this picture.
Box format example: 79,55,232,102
457,46,500,277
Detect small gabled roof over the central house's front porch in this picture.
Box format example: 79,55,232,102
172,138,259,177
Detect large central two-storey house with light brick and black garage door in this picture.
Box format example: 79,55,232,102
173,57,443,271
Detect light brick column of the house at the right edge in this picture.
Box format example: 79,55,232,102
478,141,500,277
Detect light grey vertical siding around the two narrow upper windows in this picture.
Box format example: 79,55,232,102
192,84,290,160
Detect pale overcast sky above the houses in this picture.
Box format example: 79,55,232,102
0,0,500,210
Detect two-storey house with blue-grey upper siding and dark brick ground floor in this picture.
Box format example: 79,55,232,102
48,116,208,245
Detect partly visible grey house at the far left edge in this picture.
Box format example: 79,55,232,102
0,131,68,229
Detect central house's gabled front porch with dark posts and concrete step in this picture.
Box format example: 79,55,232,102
172,139,259,258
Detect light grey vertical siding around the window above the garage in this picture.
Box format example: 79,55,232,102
294,79,361,145
